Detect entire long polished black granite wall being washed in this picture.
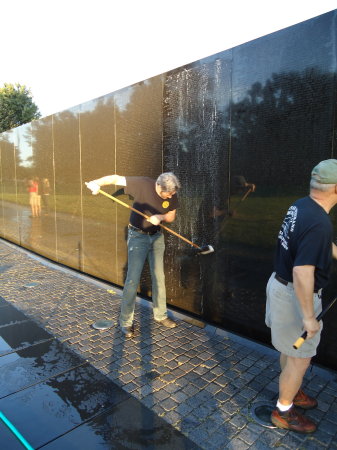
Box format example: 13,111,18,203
0,11,337,368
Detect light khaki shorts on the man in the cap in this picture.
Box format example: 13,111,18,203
265,273,322,358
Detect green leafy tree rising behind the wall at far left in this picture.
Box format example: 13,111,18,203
0,83,41,133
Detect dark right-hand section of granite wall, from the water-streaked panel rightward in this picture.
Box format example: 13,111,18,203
164,11,337,368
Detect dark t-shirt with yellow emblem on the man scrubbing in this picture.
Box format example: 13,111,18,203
124,177,178,232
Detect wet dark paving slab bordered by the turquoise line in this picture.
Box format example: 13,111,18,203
0,363,130,448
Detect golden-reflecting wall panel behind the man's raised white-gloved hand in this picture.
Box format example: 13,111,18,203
80,95,118,282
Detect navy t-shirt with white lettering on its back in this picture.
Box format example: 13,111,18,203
275,197,333,289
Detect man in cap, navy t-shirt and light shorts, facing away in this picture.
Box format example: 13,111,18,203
266,159,337,433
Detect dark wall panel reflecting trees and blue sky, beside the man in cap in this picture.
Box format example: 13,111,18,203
223,10,336,348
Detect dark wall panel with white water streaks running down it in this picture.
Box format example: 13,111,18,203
164,52,232,318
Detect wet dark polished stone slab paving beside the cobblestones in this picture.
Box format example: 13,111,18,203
0,298,198,450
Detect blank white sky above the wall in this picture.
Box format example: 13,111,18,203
0,0,337,116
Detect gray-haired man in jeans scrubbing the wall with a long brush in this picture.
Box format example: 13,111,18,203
87,172,180,338
